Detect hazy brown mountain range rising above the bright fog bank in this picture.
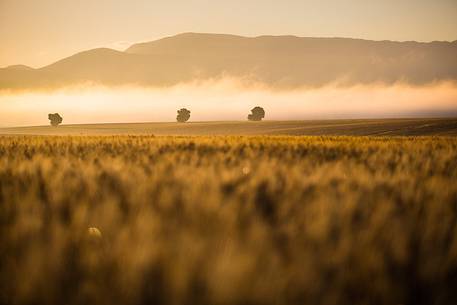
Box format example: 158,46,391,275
0,33,457,89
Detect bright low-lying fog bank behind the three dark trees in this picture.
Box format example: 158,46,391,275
0,80,457,126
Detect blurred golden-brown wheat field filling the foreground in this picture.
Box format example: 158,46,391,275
0,135,457,305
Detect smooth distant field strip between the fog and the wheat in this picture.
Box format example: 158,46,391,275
0,118,457,136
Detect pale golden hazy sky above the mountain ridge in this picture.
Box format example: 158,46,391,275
0,0,457,67
